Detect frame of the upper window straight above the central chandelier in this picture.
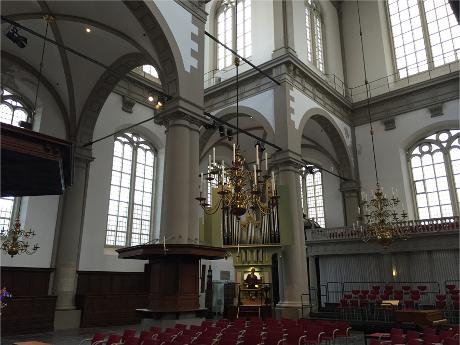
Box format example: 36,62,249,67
214,0,253,71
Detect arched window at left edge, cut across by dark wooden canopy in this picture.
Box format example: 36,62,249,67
0,88,31,230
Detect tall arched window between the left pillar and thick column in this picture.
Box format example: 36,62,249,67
105,133,156,246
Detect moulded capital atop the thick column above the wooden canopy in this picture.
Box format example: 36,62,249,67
155,97,204,127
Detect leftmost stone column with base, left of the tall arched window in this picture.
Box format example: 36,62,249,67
53,149,92,329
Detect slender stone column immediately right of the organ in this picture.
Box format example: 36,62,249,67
272,151,309,318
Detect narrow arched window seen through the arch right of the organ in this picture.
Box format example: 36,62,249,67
300,165,326,228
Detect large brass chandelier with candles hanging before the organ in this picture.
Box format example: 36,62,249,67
195,57,279,219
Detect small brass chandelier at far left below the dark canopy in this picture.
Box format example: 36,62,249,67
0,214,40,257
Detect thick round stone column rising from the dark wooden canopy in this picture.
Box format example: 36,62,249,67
157,111,200,243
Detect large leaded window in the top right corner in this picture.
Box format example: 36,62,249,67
388,0,460,78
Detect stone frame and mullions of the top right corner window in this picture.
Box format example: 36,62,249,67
385,0,460,81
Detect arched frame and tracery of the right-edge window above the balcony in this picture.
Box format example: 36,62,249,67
406,128,460,220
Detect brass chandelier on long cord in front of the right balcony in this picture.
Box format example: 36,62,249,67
353,0,408,248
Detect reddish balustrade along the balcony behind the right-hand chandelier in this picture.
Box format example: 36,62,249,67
305,216,460,243
